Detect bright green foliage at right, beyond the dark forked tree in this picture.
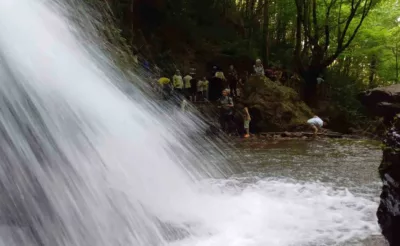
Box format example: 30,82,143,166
347,0,400,84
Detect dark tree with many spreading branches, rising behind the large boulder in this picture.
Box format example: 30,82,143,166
294,0,377,104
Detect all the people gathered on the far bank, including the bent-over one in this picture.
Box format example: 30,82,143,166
153,59,323,138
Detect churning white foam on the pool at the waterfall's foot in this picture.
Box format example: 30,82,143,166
167,179,379,246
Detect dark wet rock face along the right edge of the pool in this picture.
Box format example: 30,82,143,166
360,85,400,246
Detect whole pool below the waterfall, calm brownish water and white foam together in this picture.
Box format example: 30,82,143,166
172,139,386,246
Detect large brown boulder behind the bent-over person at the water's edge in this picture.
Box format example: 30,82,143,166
244,76,313,132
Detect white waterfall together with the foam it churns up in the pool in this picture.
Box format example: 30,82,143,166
0,0,377,246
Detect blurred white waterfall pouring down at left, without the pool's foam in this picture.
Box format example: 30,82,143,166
0,0,231,246
